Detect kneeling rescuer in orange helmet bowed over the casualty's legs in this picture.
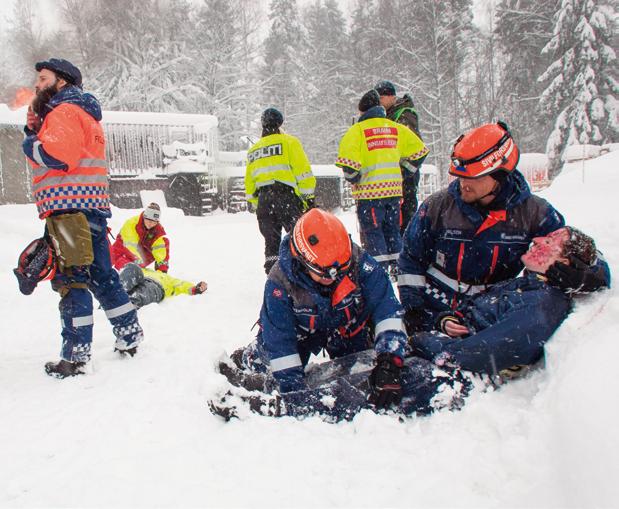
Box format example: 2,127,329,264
217,208,407,416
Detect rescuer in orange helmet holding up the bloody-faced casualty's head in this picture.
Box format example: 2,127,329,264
398,122,608,334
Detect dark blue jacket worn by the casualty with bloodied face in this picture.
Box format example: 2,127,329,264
412,273,571,374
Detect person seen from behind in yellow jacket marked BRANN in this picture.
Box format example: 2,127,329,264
335,90,429,270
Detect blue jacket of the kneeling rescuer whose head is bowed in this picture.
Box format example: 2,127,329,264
257,235,407,392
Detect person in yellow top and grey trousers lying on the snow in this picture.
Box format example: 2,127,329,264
120,263,207,308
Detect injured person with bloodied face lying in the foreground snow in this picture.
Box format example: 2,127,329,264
209,227,610,421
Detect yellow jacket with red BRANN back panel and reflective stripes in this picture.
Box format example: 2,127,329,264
335,110,429,200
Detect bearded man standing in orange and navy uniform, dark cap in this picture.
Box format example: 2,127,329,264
23,58,143,378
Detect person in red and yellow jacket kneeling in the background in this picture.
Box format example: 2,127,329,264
112,203,170,272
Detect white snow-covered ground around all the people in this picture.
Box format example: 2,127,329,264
0,152,619,508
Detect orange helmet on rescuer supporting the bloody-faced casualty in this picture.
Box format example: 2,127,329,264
449,121,520,179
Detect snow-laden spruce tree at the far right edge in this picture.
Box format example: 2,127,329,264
540,0,619,173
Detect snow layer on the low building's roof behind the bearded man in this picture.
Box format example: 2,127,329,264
0,104,218,131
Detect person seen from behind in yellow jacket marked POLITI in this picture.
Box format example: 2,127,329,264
245,108,316,274
